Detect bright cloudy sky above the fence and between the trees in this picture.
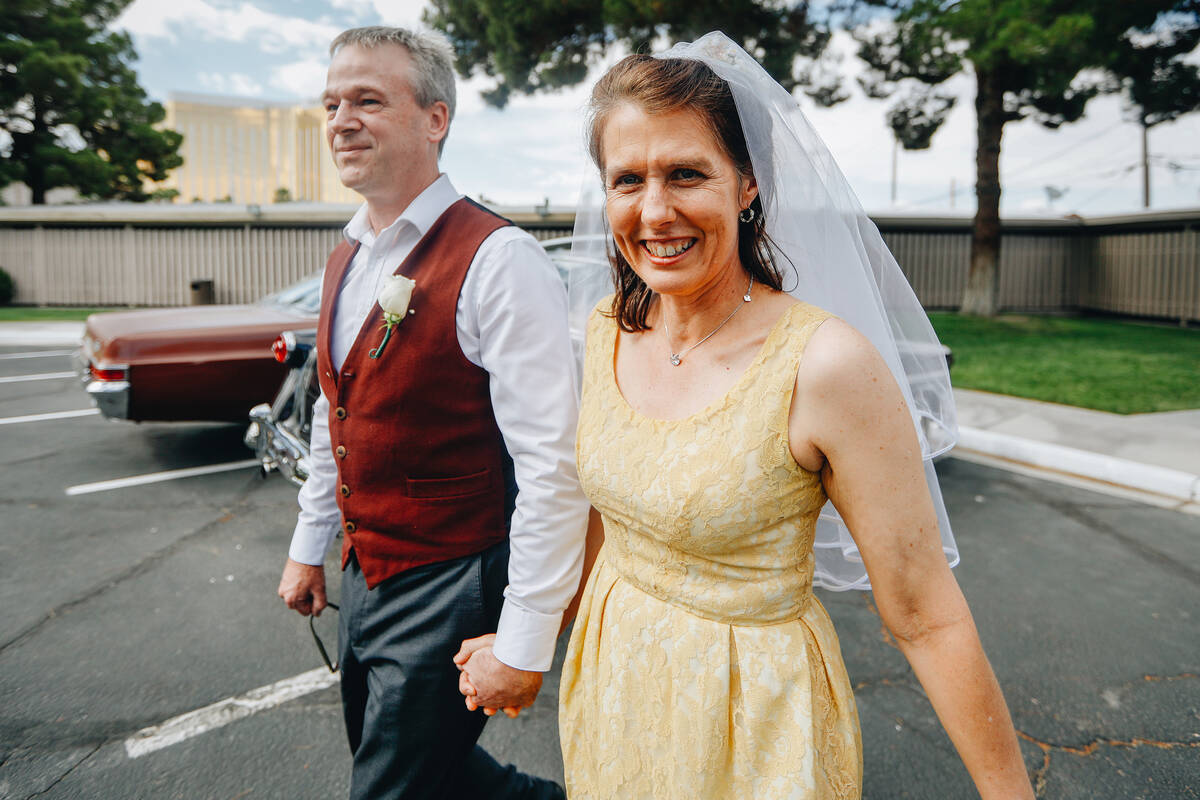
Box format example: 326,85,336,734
116,0,1200,216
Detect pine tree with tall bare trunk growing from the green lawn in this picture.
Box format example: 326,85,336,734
858,0,1196,315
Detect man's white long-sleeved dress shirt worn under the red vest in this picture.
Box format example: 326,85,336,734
288,175,588,672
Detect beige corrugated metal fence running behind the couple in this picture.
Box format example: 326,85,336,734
0,204,1200,321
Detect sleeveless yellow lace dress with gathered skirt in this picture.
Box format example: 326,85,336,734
559,301,862,800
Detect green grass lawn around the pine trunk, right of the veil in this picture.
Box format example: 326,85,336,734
929,312,1200,414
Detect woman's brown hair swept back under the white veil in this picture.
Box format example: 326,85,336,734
588,55,782,333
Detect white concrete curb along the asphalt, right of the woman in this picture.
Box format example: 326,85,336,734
950,427,1200,503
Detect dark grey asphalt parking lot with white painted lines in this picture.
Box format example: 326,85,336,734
0,347,1200,799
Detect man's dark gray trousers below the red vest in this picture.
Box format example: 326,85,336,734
338,541,564,800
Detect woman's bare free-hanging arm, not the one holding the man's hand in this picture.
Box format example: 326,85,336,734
790,319,1033,800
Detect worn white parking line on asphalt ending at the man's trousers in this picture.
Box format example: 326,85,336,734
125,667,337,758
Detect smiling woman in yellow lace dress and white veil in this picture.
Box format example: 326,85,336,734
559,35,1032,800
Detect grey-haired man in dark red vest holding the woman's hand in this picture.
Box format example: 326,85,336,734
278,28,588,800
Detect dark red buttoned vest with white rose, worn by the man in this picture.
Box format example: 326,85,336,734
317,199,510,588
